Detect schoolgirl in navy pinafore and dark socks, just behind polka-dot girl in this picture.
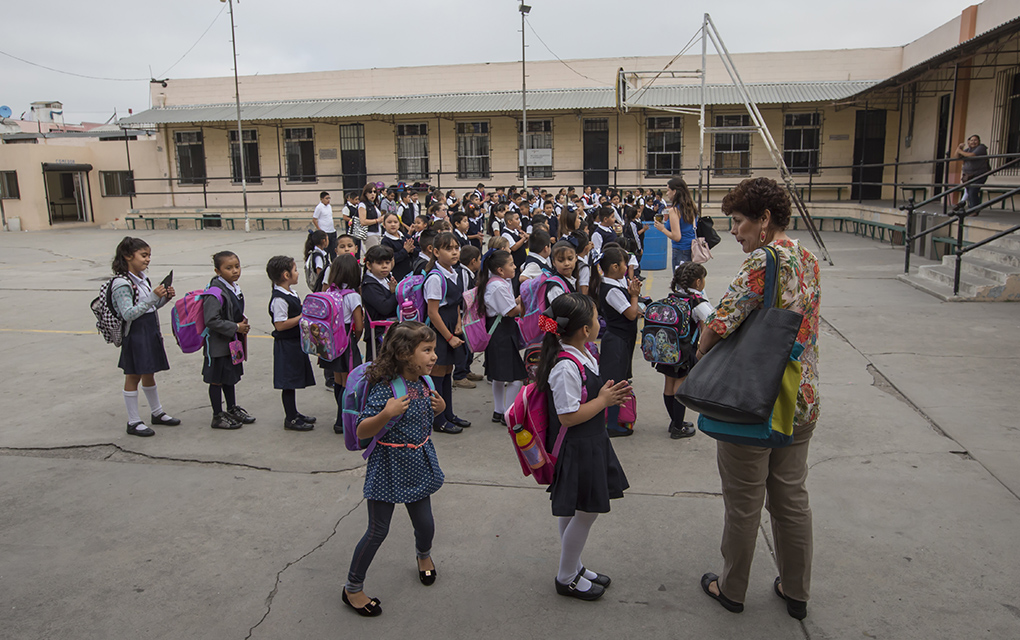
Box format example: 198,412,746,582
422,232,471,434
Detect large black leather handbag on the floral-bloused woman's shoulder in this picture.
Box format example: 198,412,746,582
676,247,804,425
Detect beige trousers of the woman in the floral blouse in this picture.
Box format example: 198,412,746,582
716,424,815,602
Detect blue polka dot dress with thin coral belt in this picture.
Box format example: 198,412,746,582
360,380,444,504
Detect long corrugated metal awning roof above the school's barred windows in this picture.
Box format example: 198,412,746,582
120,81,875,125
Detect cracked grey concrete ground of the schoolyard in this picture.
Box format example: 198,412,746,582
0,230,1020,640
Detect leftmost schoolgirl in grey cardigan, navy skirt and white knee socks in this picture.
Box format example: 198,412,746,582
110,237,181,437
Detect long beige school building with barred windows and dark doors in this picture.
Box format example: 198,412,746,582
0,0,1020,230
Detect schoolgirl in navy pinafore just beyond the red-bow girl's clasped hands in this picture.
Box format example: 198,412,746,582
589,247,641,438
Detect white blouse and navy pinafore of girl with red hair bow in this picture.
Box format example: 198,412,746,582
546,345,630,516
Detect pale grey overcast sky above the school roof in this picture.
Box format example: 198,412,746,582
0,0,976,124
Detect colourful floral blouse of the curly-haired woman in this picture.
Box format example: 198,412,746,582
707,239,821,426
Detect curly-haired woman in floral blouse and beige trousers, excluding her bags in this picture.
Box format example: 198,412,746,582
698,178,821,620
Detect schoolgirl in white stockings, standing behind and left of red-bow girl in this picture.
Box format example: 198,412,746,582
475,251,527,425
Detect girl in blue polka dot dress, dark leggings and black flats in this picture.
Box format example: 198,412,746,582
343,322,446,616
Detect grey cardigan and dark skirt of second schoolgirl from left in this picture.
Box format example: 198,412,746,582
202,277,244,386
